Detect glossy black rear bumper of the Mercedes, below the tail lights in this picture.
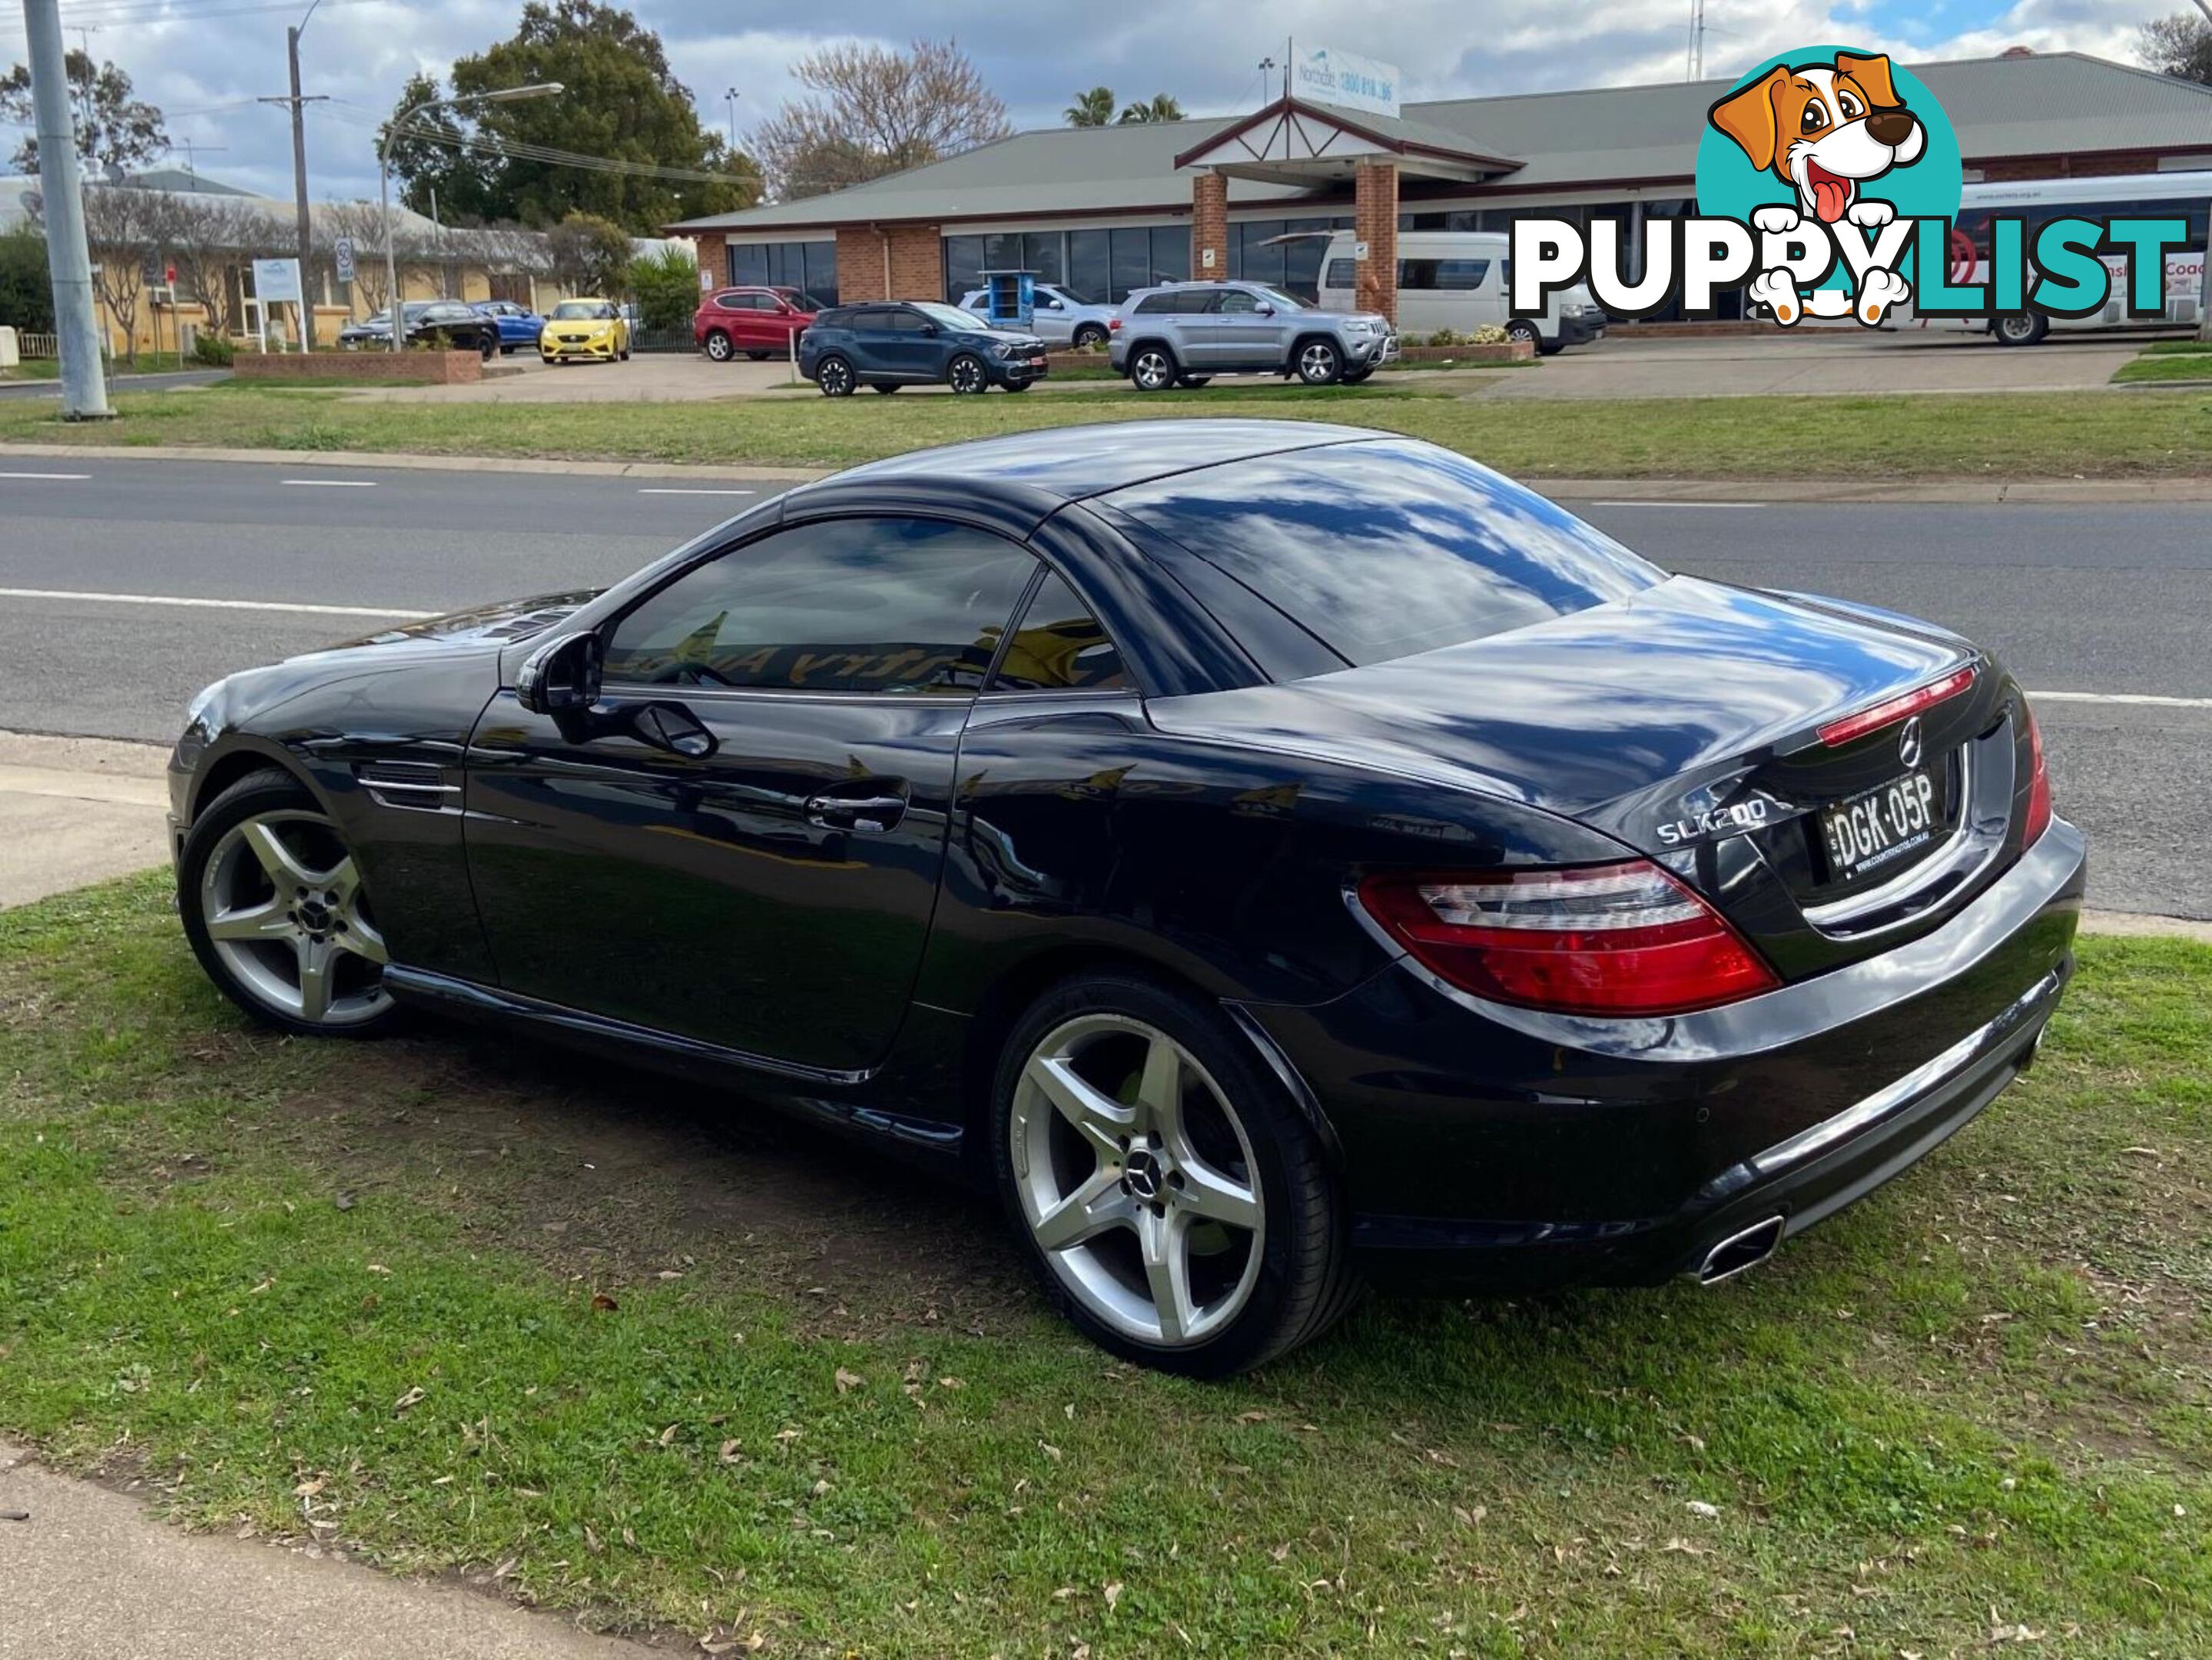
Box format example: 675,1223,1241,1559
1248,821,2086,1290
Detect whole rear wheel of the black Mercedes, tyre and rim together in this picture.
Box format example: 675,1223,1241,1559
991,974,1358,1376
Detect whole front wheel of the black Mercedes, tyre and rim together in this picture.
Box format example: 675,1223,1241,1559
177,768,398,1038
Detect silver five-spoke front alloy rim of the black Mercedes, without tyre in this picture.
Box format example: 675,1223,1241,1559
199,808,390,1027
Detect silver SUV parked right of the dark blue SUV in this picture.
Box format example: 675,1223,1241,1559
1108,284,1398,392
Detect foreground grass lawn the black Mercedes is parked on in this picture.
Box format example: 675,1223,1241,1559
0,876,2212,1660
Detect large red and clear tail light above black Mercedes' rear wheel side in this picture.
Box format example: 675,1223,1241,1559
1361,858,1781,1016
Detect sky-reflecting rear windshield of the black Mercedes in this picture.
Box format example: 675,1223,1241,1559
1106,438,1666,666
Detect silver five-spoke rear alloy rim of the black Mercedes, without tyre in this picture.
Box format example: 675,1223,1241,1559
1009,1014,1265,1348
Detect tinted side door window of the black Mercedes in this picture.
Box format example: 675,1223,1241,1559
606,518,1037,697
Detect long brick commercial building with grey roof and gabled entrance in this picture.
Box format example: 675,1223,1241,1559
668,51,2212,325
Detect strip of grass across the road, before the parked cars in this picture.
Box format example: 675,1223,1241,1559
0,383,2212,480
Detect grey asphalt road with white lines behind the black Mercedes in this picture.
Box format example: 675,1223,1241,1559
0,456,2212,918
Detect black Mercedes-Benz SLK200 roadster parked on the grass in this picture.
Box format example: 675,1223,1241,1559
171,420,2084,1374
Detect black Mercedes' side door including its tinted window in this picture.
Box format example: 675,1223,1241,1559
465,516,1037,1071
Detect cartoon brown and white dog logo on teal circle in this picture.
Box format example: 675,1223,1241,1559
1699,46,1962,327
